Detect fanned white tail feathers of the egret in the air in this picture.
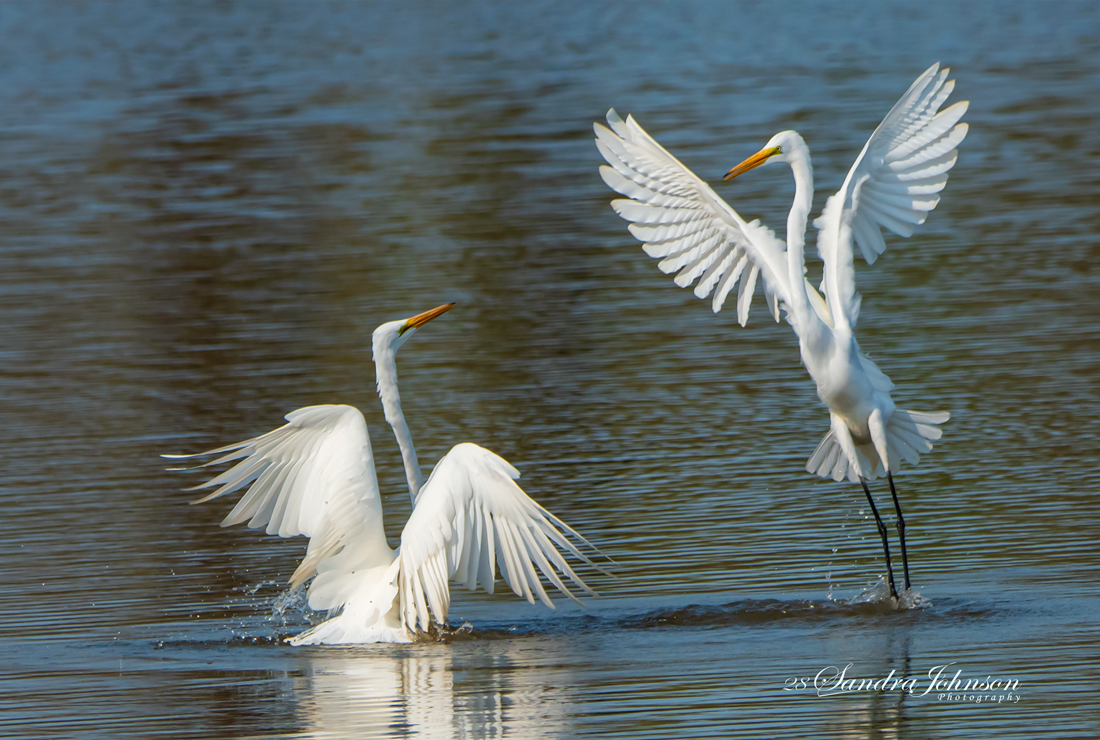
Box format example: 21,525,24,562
806,409,952,483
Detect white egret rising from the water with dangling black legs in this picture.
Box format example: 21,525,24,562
595,63,967,598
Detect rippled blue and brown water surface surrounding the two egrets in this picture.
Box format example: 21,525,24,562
0,2,1100,739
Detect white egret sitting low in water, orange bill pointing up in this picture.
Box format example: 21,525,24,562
165,303,602,644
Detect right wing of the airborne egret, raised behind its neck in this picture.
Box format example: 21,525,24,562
814,62,969,327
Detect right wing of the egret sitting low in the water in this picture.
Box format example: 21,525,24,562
398,443,598,630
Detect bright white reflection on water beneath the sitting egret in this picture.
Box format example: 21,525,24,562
299,643,571,739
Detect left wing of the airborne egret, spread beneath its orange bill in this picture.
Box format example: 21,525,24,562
593,109,789,327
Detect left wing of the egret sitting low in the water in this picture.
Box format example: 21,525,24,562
164,406,392,609
